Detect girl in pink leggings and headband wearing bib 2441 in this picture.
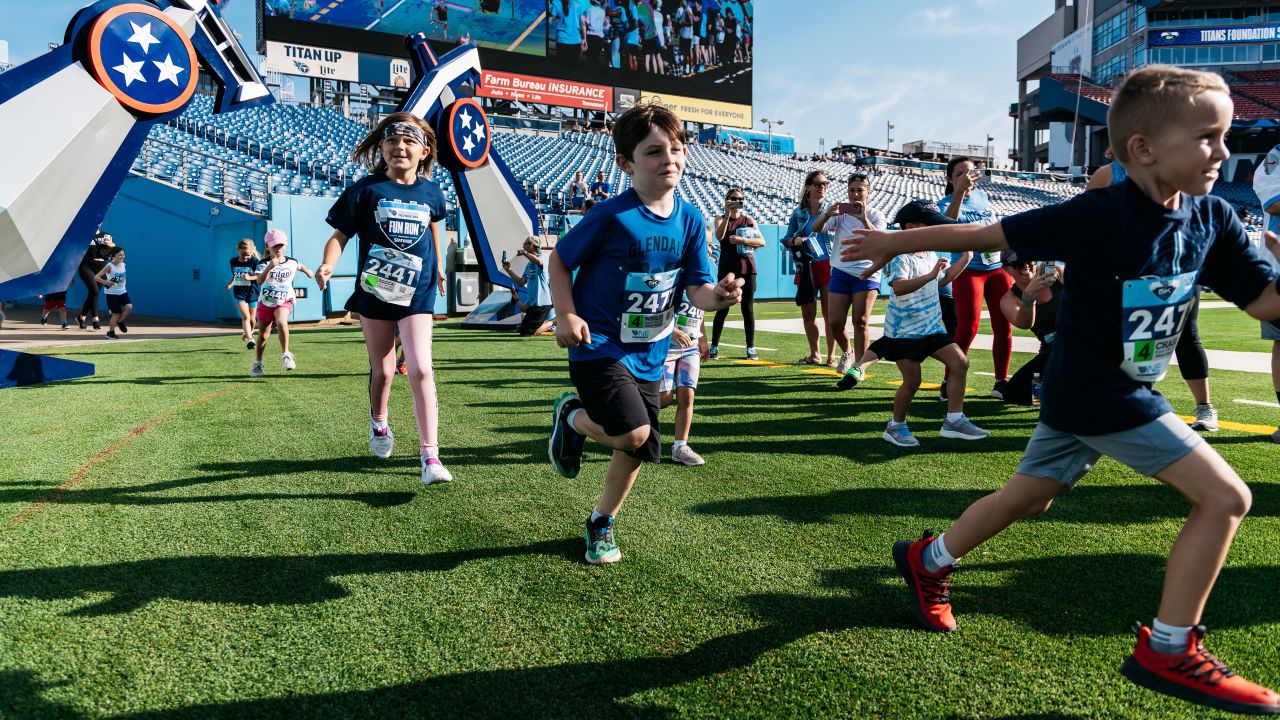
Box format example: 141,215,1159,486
316,113,453,484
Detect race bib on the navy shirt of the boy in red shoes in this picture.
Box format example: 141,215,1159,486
1120,273,1196,383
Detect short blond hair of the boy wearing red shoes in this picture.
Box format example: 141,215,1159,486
1107,65,1231,163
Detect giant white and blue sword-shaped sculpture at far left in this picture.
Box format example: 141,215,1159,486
0,0,274,387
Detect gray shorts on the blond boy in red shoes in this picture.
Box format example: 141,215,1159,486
1018,413,1204,487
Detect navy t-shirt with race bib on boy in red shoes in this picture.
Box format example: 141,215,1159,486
1001,179,1275,436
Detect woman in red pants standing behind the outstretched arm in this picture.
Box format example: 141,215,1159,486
938,158,1014,400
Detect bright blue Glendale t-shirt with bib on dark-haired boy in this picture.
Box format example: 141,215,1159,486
556,190,716,380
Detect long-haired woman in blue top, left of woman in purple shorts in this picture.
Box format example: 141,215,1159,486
782,170,835,365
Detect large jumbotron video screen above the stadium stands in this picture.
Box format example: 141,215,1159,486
259,0,755,114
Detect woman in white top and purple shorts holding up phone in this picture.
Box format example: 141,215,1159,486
813,173,888,374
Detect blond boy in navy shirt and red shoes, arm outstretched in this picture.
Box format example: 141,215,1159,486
844,65,1280,714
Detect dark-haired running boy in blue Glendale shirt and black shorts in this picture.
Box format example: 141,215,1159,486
548,105,742,565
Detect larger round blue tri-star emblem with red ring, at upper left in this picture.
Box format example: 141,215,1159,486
88,3,198,114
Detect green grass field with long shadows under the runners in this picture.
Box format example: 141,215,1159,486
0,315,1280,720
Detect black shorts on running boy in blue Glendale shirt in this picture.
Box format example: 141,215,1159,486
568,357,662,462
